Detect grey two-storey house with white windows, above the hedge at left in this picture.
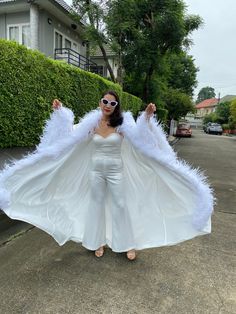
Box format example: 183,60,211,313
0,0,96,71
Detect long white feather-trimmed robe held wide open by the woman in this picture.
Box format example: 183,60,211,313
0,107,214,249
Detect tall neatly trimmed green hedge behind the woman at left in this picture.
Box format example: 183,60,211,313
0,40,142,148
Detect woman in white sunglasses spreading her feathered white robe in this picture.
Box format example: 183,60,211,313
0,91,214,260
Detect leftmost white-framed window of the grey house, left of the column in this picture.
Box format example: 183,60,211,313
7,24,30,47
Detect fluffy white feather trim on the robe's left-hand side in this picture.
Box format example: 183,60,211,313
0,107,101,209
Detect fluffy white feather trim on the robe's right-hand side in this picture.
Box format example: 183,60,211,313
121,113,216,230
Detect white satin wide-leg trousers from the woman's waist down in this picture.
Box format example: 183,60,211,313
82,159,135,252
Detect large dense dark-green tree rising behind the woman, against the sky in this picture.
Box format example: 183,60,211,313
107,0,202,106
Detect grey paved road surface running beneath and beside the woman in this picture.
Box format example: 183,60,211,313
0,130,236,314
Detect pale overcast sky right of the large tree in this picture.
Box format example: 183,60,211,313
65,0,236,97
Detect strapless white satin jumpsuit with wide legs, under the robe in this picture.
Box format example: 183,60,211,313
82,133,135,252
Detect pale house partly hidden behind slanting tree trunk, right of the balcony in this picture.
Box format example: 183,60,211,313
90,45,118,77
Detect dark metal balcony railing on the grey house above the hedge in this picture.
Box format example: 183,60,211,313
54,48,98,73
